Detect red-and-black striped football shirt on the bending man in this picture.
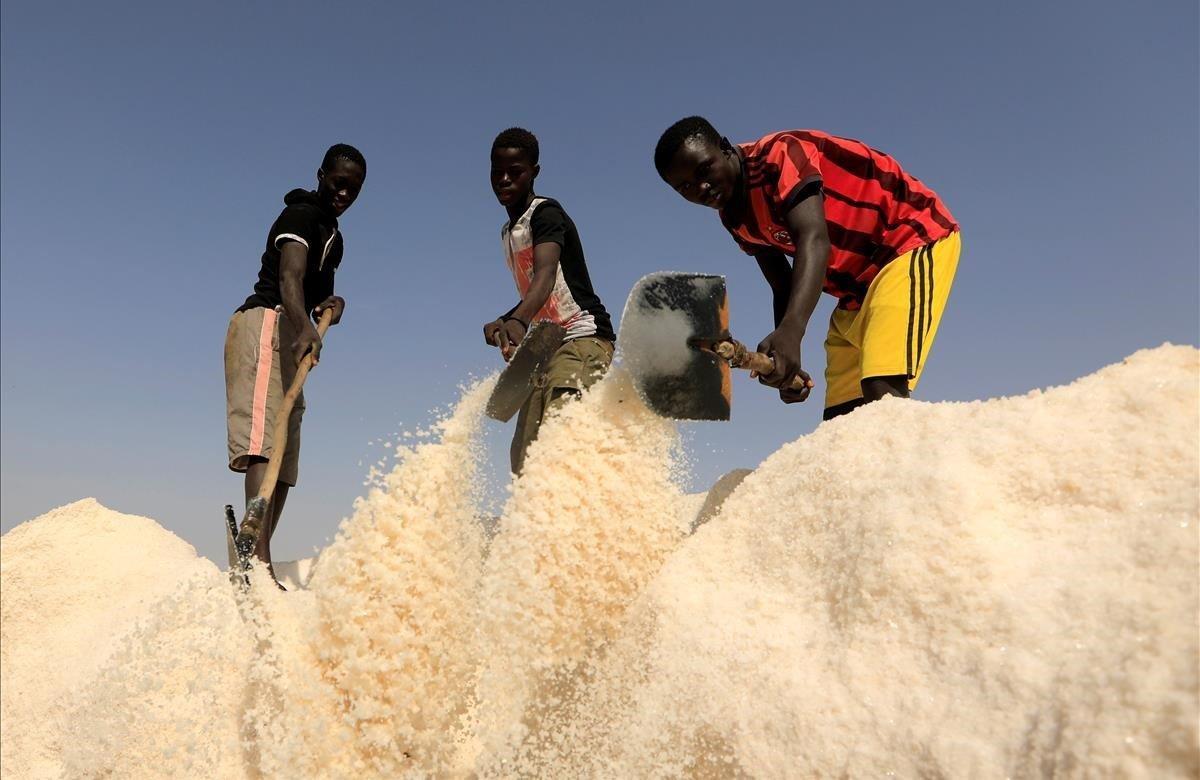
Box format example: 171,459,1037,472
721,130,959,311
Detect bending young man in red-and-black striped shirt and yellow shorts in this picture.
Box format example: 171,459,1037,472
654,116,960,420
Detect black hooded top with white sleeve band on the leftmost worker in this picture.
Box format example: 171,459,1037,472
238,190,342,313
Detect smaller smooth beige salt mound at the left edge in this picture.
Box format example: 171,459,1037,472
0,498,216,778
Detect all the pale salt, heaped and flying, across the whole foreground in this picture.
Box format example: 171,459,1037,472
0,347,1200,778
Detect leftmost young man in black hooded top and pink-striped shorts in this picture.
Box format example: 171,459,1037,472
224,144,367,566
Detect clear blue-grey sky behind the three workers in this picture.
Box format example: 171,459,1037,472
0,0,1200,563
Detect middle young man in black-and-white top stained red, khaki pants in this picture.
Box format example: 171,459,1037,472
484,127,616,474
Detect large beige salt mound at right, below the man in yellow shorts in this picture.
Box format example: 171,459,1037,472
522,347,1200,778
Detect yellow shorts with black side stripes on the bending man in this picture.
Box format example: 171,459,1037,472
826,232,962,418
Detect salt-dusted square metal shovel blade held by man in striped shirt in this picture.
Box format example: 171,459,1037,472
618,271,732,420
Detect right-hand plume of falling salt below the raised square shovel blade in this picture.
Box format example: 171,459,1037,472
472,370,686,768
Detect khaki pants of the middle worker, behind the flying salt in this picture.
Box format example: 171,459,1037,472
509,336,613,474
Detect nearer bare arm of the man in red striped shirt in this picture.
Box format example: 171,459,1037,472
758,197,829,403
